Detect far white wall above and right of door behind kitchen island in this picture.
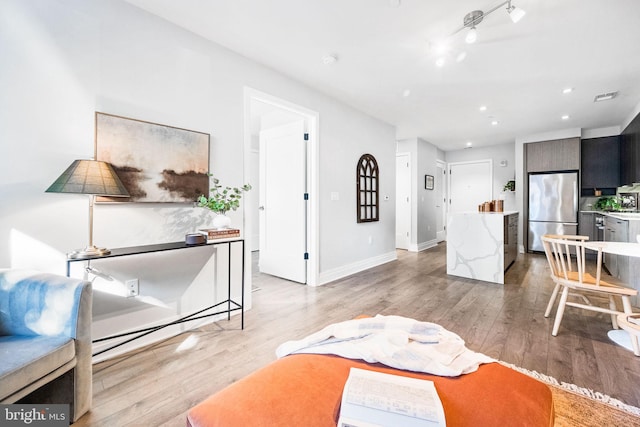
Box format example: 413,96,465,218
445,144,522,211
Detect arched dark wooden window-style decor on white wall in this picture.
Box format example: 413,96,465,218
356,154,380,222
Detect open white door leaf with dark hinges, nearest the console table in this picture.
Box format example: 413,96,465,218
259,120,307,283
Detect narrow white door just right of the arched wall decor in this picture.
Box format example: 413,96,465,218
396,153,411,249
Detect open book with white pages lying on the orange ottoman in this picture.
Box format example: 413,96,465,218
338,368,446,427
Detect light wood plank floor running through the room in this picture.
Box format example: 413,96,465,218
74,244,640,426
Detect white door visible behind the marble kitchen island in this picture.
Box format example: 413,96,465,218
449,159,493,212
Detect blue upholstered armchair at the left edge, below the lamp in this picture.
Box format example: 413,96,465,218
0,269,92,421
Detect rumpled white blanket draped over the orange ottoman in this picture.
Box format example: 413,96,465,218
276,315,495,377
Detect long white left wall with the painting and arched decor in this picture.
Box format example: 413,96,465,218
0,0,395,358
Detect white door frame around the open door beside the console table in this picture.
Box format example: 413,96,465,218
243,86,320,286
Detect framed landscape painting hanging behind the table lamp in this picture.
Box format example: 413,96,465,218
95,112,210,203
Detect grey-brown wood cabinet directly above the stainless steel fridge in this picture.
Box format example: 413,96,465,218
525,138,580,172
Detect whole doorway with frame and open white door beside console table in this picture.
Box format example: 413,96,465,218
244,88,318,286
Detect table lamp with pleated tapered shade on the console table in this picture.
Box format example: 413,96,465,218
46,160,129,258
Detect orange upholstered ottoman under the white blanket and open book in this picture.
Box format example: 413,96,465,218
187,354,554,427
